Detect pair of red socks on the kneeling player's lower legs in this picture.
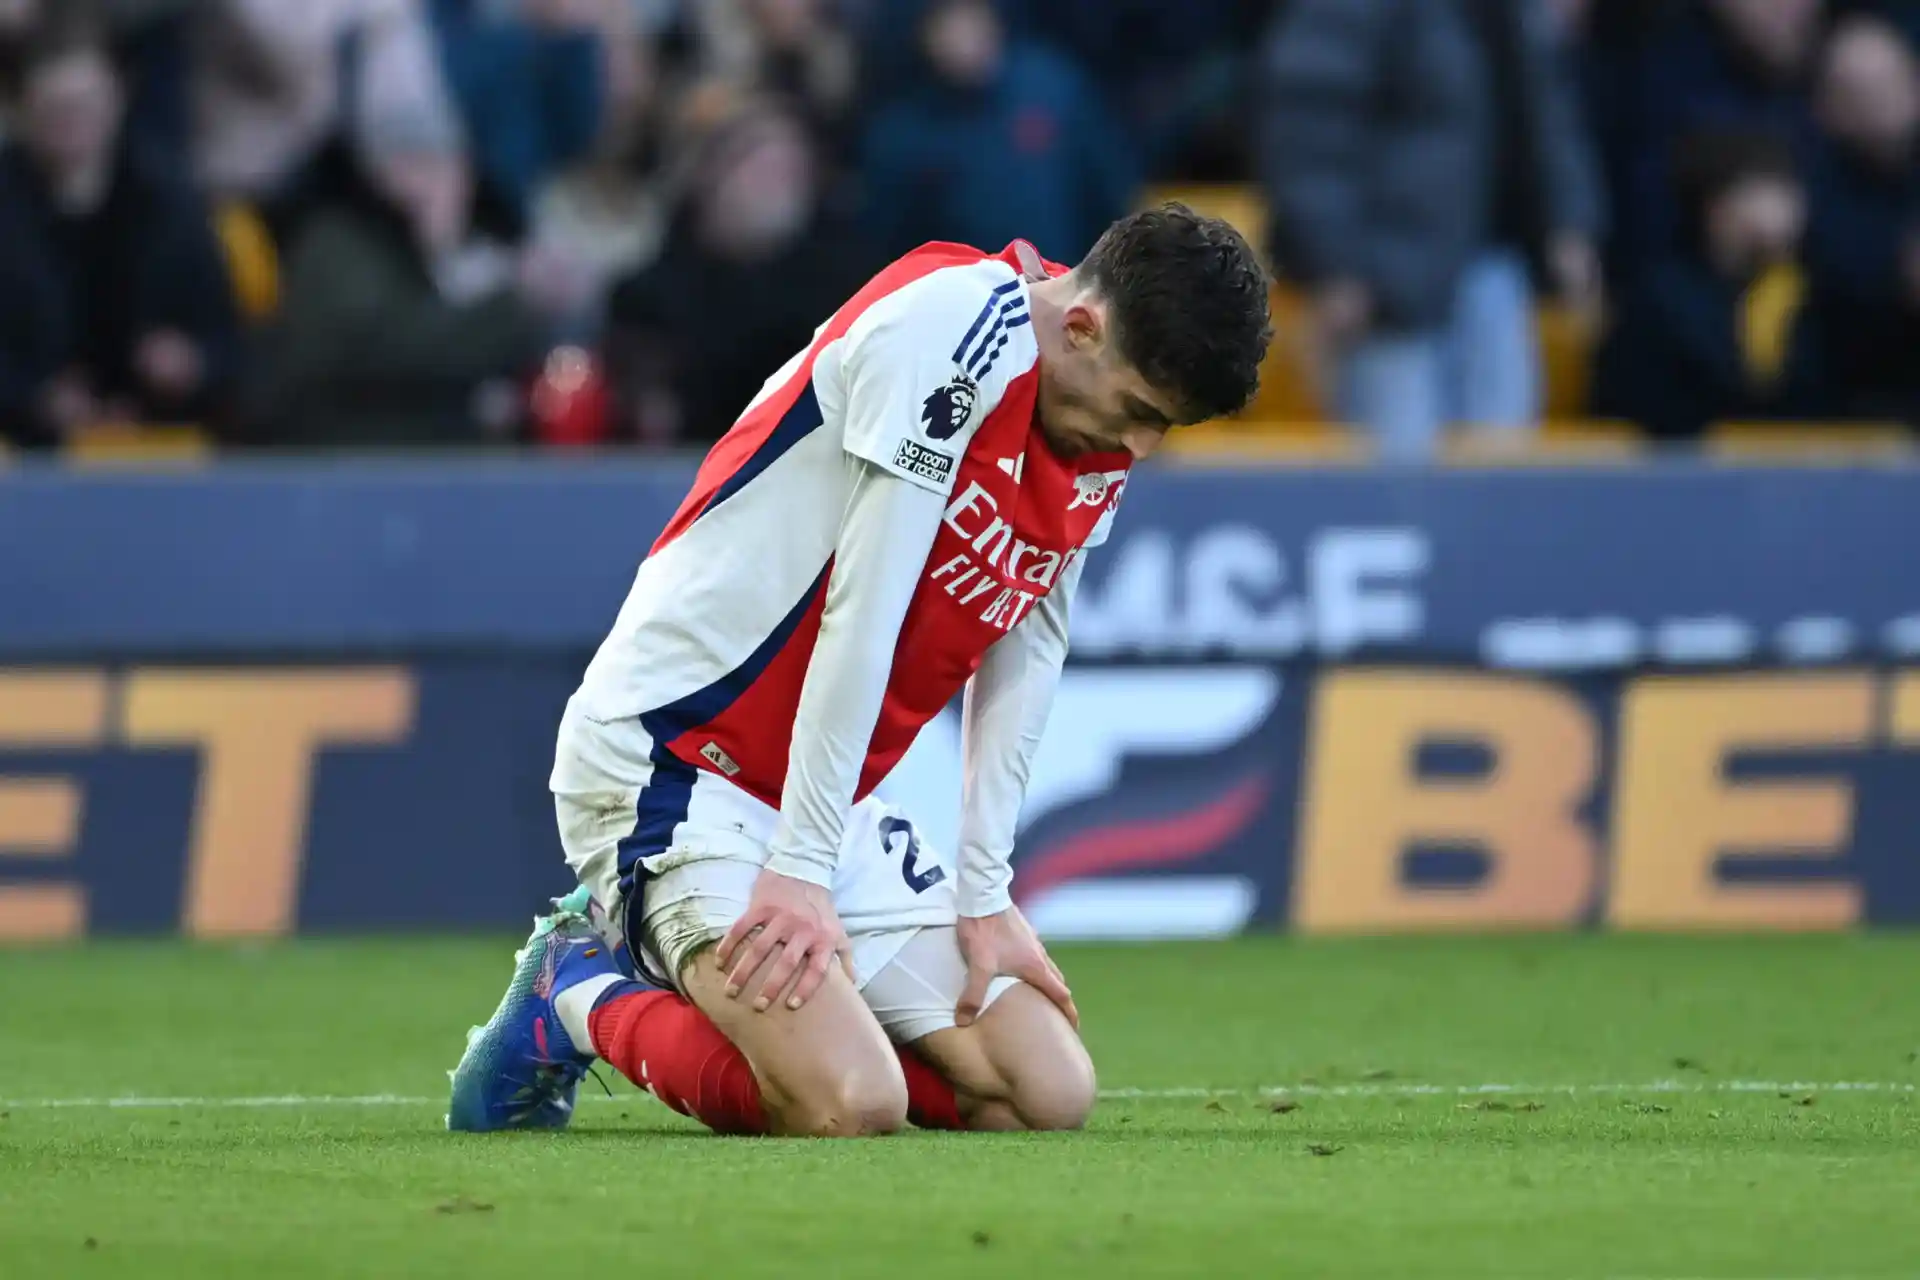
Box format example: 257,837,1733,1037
588,990,964,1134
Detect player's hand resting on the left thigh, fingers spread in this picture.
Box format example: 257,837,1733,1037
716,871,852,1013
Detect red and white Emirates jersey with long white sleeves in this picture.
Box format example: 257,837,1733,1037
580,244,1133,913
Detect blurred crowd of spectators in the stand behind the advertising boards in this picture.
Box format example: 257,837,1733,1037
0,0,1920,459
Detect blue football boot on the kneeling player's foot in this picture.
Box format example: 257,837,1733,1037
447,887,632,1132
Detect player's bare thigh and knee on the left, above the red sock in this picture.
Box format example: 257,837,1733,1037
680,948,906,1138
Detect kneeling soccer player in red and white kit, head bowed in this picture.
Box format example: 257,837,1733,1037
447,205,1271,1136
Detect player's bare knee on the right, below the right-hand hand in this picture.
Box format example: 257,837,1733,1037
912,983,1096,1130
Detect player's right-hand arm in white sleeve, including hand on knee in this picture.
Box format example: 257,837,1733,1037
954,557,1083,1027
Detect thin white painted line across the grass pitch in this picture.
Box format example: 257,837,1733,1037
0,1080,1920,1111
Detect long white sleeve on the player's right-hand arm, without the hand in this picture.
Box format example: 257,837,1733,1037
958,557,1085,915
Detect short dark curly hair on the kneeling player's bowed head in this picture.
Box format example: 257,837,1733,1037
1079,203,1273,422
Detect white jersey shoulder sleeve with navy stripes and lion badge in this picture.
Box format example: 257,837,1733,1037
843,261,1033,497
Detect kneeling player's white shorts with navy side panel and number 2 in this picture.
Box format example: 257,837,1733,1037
551,702,1016,1042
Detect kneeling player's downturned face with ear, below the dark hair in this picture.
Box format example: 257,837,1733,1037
1039,305,1179,459
